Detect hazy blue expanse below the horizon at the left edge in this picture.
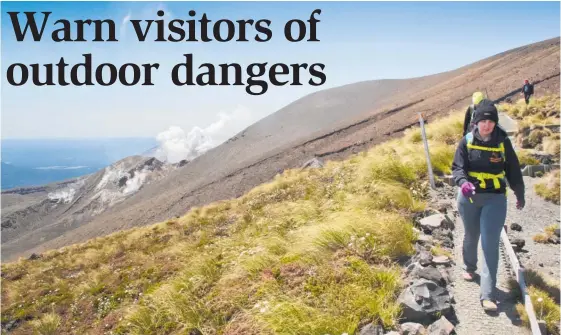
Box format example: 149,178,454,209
0,138,158,190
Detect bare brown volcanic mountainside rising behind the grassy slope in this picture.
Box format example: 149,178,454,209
2,38,560,260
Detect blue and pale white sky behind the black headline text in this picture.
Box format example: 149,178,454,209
1,2,560,138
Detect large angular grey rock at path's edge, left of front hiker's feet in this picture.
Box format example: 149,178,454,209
398,279,452,322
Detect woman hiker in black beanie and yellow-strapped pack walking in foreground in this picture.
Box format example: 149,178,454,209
452,100,525,312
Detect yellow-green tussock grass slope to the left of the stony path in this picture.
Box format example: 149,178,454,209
2,96,556,334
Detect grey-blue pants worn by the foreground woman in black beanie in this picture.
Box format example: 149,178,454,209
457,191,507,300
